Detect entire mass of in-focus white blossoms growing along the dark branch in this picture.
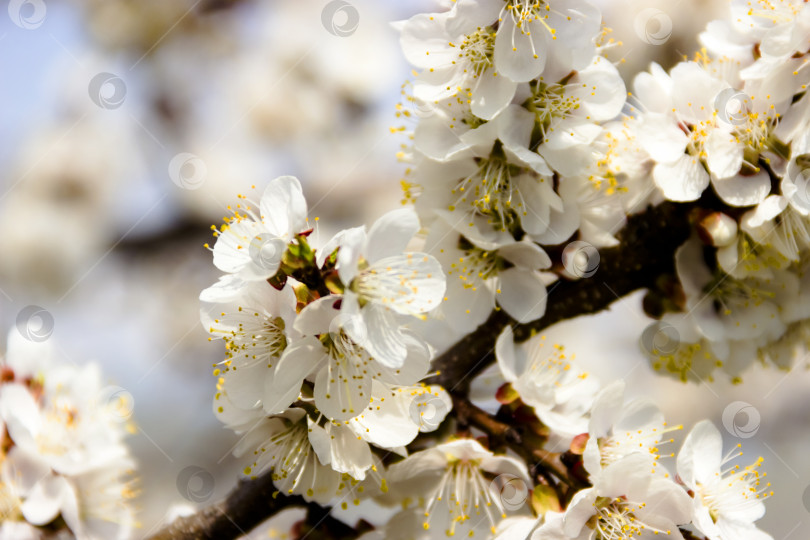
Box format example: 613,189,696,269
194,0,796,540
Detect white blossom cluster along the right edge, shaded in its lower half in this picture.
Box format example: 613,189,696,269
632,0,810,381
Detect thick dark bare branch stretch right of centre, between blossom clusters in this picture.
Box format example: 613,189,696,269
430,201,693,396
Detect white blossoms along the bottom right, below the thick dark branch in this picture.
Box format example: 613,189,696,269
352,330,772,540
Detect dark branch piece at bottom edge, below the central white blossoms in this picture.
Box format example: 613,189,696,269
149,472,357,540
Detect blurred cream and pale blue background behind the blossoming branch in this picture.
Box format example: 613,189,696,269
0,0,810,539
